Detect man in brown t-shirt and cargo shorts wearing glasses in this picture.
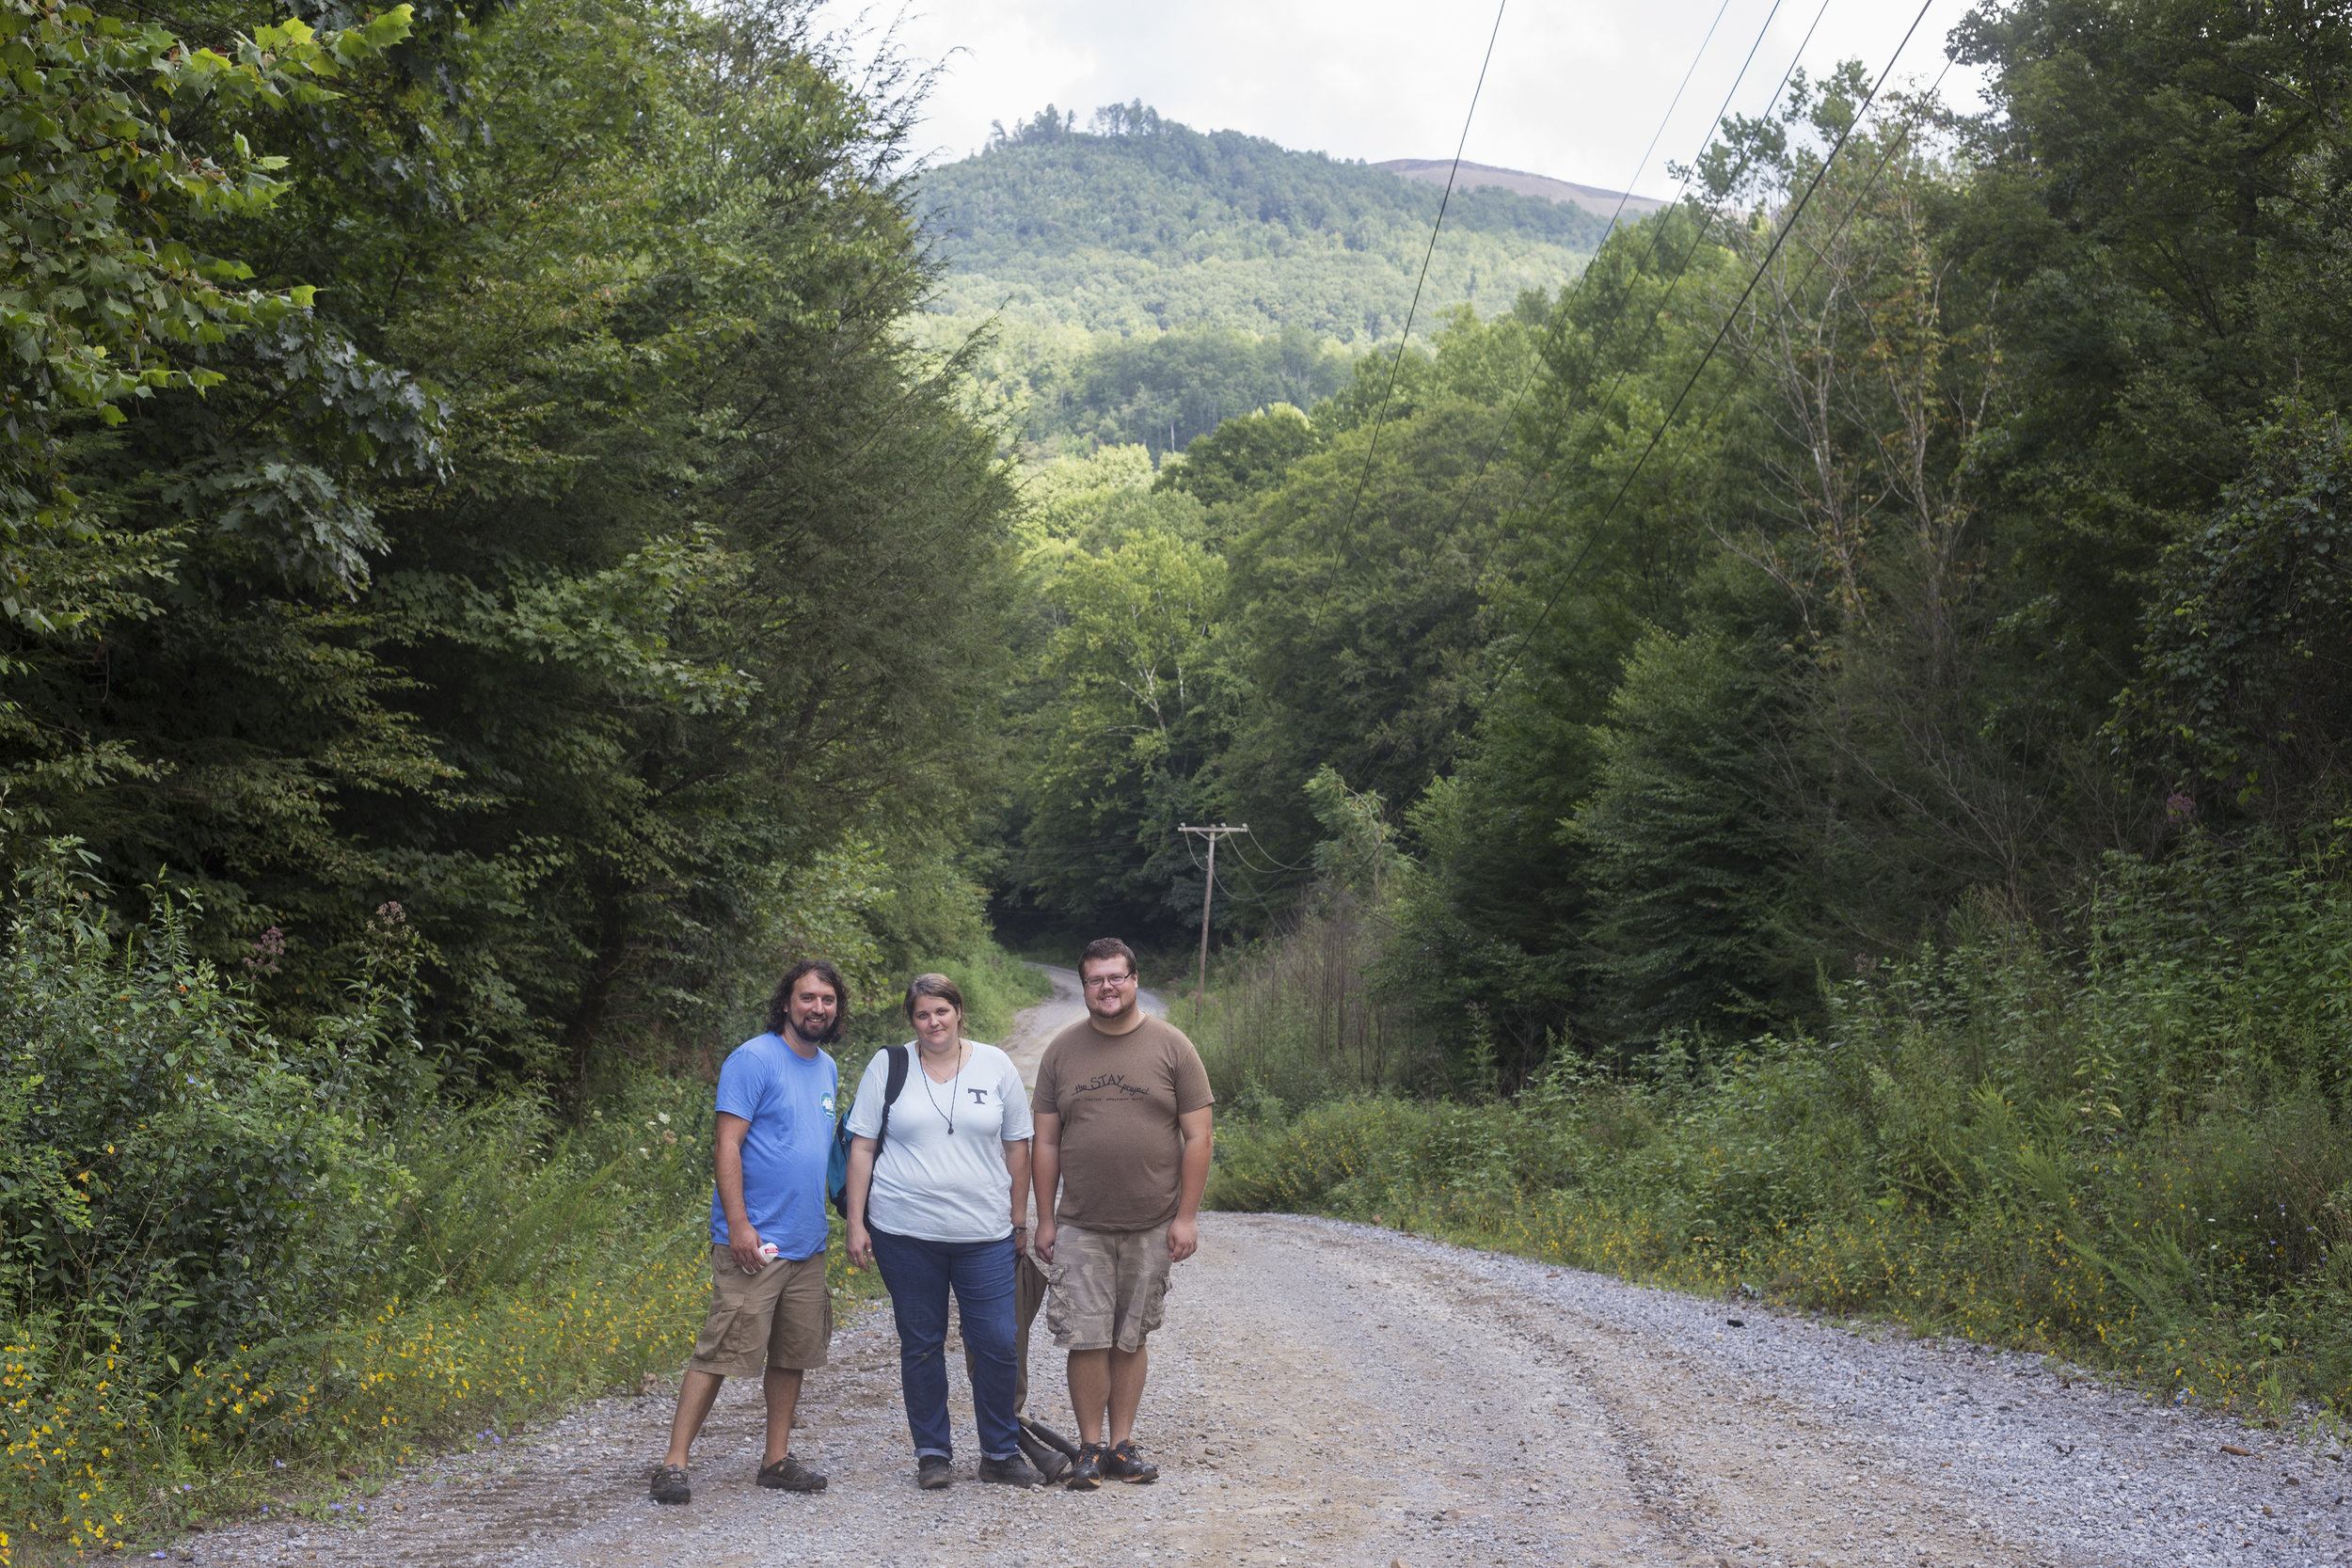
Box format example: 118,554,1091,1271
1030,936,1216,1491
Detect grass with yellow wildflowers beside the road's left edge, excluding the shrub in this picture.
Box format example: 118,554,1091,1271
0,1079,898,1563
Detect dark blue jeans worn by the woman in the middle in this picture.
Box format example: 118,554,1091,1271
868,1227,1021,1460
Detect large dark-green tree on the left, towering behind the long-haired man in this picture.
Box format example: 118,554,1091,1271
17,0,1011,1079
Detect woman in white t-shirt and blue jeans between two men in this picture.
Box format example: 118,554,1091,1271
847,975,1044,1491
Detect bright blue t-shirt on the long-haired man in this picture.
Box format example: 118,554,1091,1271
710,1035,842,1262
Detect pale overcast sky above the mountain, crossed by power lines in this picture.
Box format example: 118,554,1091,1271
823,0,1979,195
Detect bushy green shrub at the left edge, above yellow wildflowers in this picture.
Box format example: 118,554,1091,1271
0,844,428,1361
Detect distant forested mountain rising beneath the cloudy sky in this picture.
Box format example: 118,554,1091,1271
920,103,1607,453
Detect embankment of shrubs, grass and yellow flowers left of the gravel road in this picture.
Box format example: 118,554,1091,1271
0,889,1042,1566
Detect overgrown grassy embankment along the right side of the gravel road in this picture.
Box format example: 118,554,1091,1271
1204,861,2352,1425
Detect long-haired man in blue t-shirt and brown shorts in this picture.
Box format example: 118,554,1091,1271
652,959,850,1502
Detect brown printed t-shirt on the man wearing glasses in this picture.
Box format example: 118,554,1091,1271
1030,1016,1216,1229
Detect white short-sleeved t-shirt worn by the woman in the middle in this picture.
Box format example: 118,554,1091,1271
850,1039,1033,1242
